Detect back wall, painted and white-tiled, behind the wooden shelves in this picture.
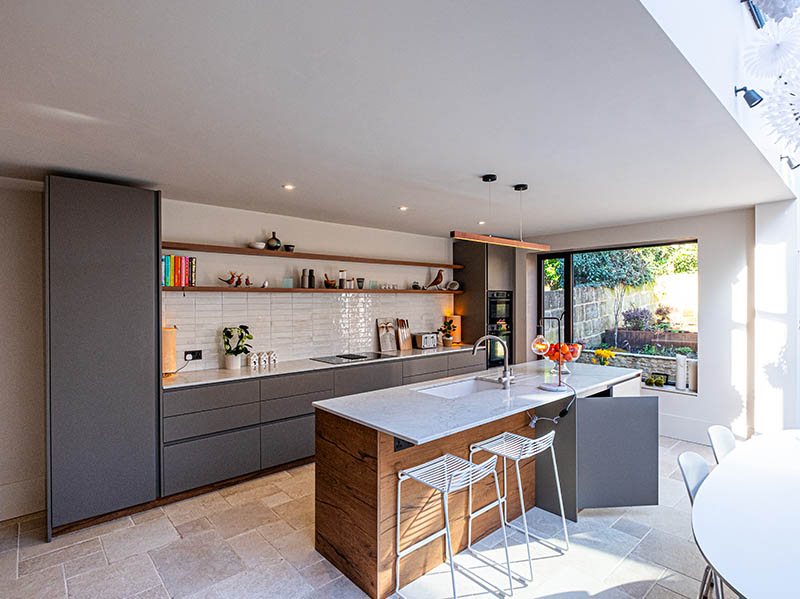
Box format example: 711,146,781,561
162,200,453,370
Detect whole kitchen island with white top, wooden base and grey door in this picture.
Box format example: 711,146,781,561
314,361,658,599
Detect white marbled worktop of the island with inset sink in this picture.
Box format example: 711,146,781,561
313,360,642,445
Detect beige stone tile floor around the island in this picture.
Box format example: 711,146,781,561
0,437,735,599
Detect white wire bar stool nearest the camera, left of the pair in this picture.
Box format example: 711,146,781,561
395,453,513,599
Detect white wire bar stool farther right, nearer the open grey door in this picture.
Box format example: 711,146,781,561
467,431,569,581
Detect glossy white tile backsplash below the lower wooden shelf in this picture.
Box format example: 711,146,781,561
162,292,453,371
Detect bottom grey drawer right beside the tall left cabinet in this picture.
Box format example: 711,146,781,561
162,427,261,495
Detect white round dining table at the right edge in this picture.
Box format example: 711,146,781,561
692,430,800,599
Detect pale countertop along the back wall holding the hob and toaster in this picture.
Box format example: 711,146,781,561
161,344,483,389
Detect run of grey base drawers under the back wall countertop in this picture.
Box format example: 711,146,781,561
162,350,478,495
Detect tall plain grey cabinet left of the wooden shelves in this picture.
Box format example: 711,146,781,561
44,176,161,535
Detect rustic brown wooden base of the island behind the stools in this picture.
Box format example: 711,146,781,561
315,409,535,599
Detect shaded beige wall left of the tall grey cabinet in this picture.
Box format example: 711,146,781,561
0,189,45,520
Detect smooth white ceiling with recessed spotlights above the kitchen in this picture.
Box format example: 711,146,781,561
0,0,793,237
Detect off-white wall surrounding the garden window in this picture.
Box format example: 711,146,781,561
518,209,754,443
